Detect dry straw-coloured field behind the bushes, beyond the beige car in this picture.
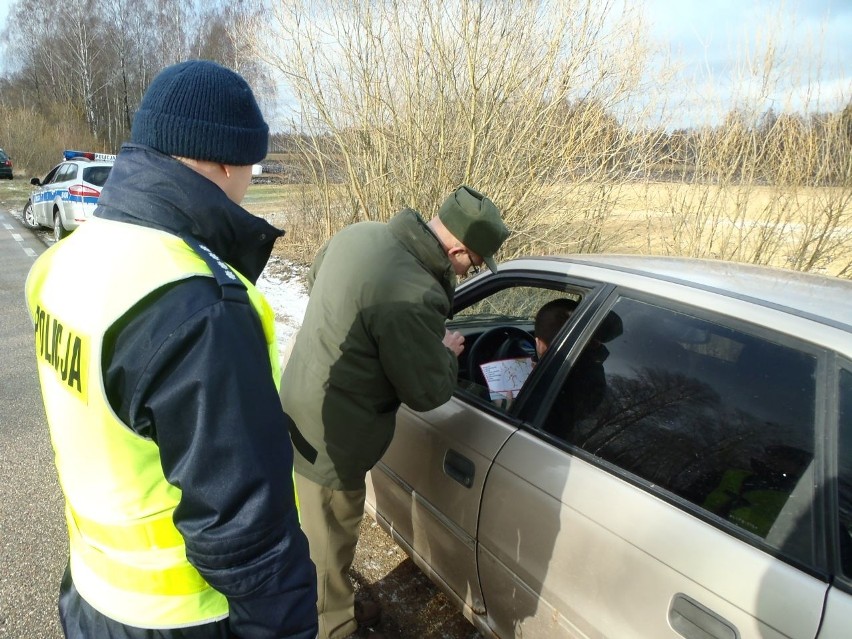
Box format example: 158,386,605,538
253,182,852,277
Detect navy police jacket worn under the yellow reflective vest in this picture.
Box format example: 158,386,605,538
60,145,317,639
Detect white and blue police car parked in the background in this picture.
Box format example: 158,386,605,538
22,151,115,242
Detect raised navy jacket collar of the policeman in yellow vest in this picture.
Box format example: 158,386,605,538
95,144,284,282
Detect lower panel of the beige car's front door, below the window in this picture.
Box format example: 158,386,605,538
368,397,516,614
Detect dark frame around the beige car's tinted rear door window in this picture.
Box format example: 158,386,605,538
522,286,838,582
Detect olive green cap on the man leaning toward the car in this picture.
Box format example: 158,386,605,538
438,186,509,273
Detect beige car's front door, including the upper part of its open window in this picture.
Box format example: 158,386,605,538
367,272,604,614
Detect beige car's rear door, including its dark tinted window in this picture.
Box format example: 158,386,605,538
478,292,832,639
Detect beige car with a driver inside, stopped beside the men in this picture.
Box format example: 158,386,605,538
368,256,852,639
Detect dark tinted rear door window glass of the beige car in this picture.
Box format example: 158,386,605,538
543,297,816,561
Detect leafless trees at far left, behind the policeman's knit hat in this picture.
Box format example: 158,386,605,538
0,0,268,173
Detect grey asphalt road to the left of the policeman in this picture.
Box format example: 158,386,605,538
0,210,68,639
